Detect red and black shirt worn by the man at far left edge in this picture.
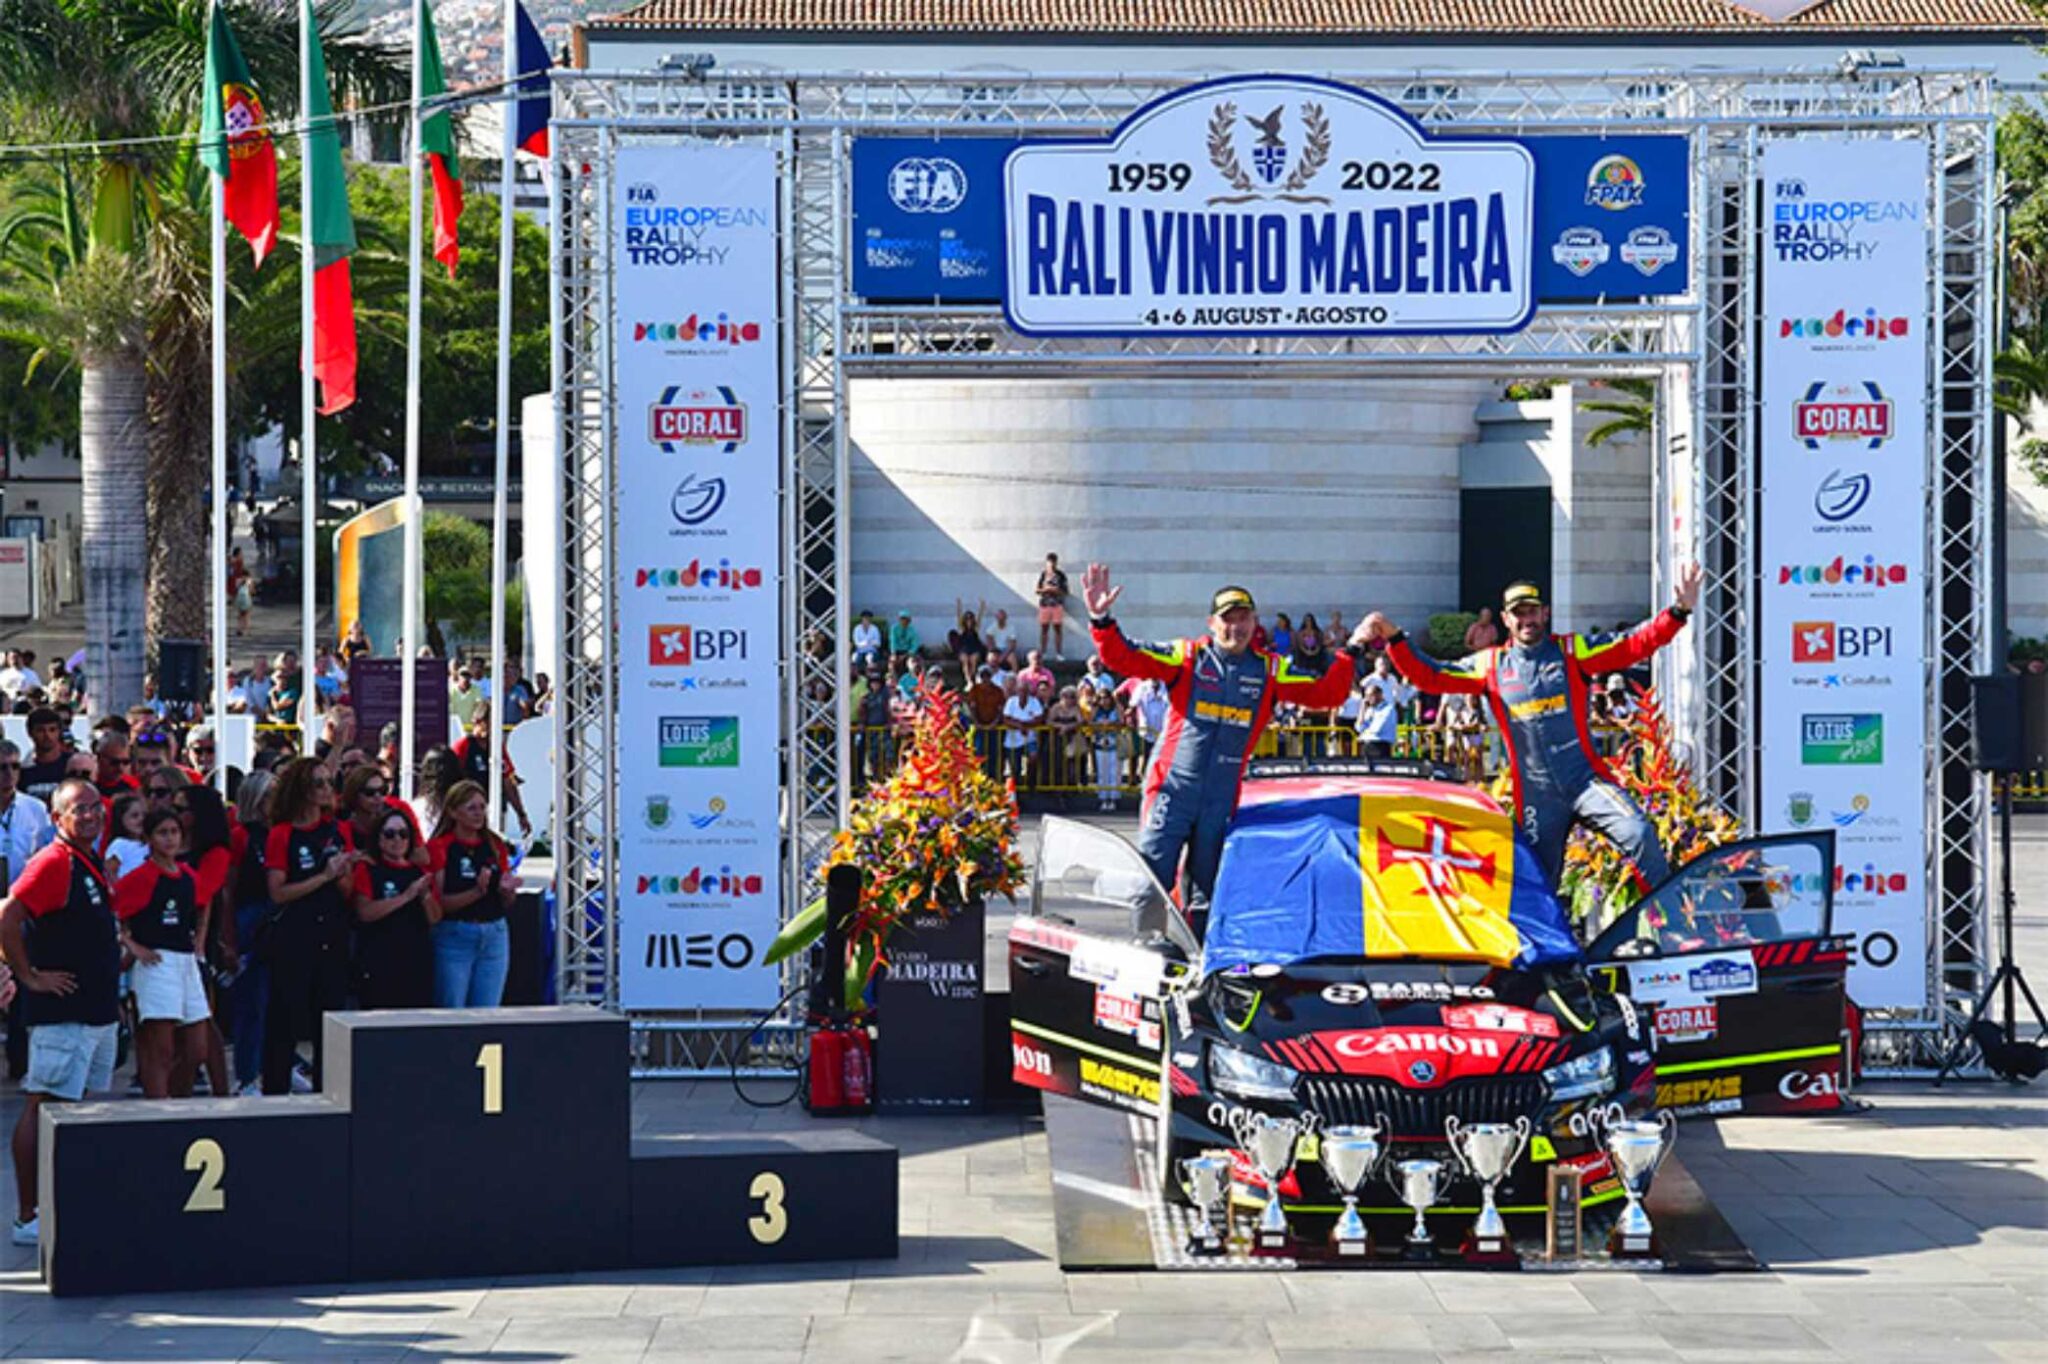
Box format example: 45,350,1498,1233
8,838,121,1028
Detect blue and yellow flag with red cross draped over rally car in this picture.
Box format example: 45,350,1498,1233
1204,778,1579,971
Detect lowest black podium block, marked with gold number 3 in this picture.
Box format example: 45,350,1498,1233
633,1131,897,1270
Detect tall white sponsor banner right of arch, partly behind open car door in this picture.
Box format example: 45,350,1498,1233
1757,137,1929,1008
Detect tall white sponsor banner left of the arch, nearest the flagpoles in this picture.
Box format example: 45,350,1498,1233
612,145,782,1010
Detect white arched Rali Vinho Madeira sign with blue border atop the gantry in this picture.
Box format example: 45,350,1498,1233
1004,76,1536,336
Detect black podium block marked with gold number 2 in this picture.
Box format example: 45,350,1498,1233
37,1096,350,1296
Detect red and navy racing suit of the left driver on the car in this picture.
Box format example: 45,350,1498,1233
1090,619,1352,907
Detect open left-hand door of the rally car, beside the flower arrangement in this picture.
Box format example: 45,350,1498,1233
1010,815,1198,1114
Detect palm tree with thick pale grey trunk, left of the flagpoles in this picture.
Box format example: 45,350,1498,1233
0,0,406,711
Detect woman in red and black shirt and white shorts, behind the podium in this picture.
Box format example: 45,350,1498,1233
115,809,213,1098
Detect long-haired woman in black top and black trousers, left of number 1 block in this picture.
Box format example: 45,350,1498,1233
262,758,362,1094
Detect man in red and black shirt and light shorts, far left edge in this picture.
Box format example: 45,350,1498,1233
0,780,121,1245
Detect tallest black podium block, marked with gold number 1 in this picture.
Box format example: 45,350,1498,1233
326,1008,631,1280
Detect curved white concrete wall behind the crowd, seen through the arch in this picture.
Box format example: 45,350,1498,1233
850,379,1493,657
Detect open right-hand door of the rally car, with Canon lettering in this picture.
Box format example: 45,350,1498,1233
1587,829,1849,1116
